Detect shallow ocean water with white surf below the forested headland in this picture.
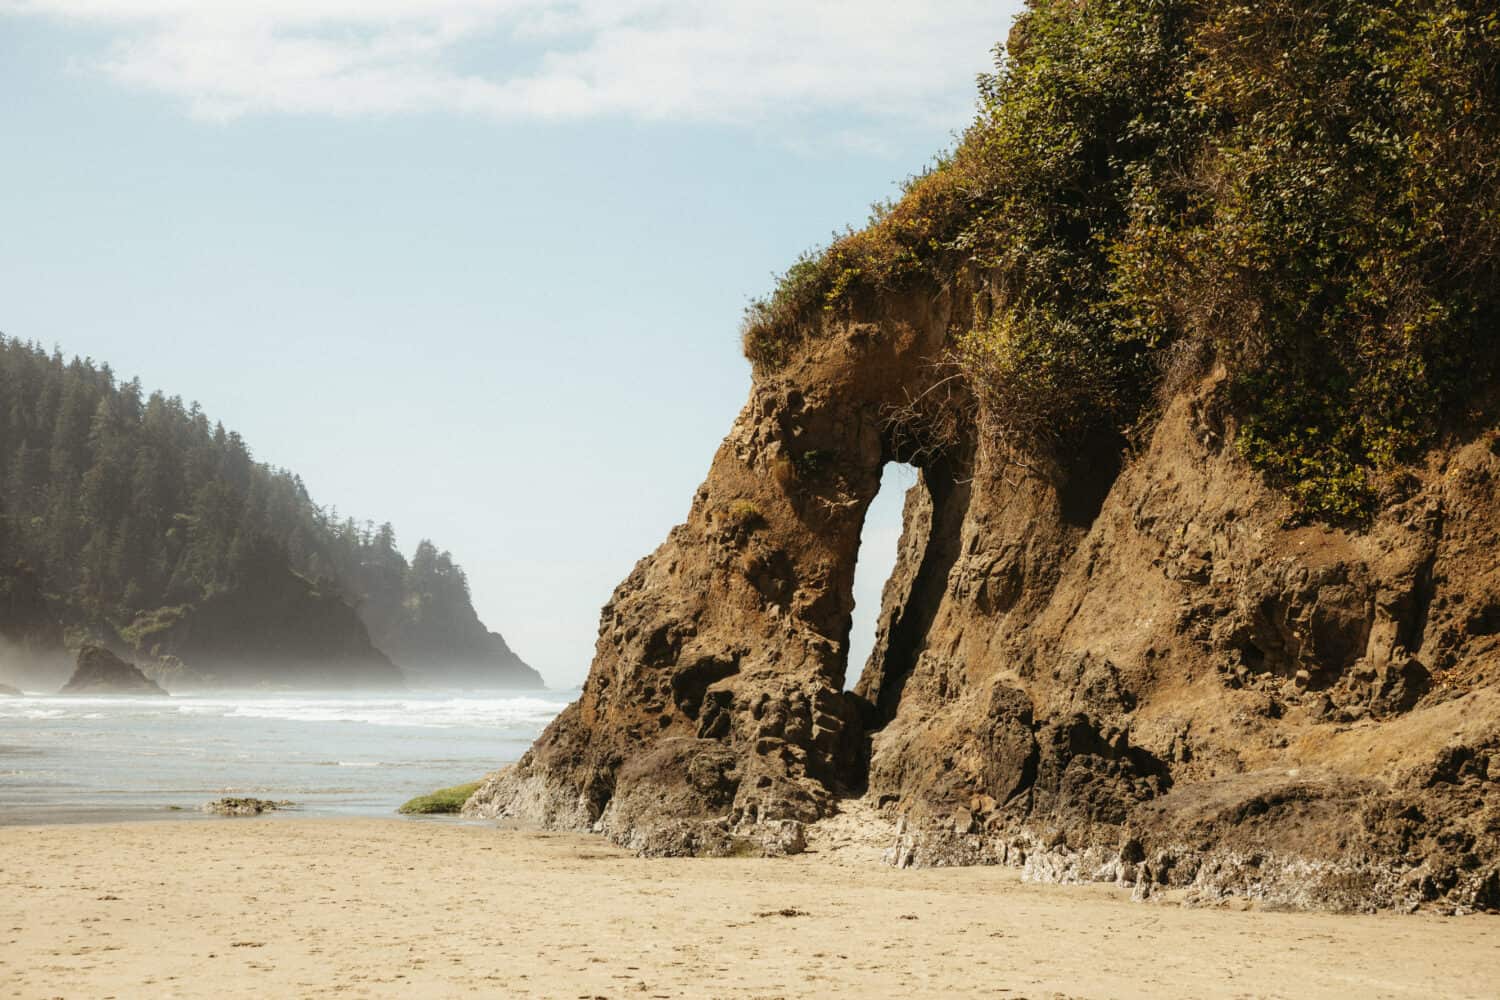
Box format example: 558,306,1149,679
0,690,578,825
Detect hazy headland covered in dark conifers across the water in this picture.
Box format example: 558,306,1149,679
0,337,540,687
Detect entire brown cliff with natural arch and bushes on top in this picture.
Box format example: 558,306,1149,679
465,0,1500,910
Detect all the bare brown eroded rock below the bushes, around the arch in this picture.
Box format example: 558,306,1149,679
467,277,1500,909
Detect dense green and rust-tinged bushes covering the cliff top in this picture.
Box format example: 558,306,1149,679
746,0,1500,520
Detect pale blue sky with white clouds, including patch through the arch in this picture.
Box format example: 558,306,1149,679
0,0,1019,687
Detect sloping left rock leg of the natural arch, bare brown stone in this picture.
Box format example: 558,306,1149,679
467,287,951,855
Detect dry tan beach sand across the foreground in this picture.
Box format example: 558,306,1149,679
0,817,1500,999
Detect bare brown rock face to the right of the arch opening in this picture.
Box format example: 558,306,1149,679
867,364,1500,909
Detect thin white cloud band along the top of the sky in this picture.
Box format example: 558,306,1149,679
0,0,1019,124
